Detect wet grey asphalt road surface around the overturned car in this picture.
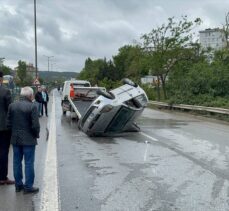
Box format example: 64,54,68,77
0,91,229,211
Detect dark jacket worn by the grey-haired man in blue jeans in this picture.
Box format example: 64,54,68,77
7,97,40,145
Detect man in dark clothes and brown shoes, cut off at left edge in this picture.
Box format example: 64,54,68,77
0,72,14,185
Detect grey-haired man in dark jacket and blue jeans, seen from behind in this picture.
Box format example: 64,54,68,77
7,87,40,193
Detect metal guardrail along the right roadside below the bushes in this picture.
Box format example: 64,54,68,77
149,101,229,114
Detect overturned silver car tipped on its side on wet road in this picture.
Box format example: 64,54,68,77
79,79,148,136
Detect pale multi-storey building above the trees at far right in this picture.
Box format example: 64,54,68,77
199,28,227,50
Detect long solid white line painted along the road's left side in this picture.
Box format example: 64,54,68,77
40,94,60,211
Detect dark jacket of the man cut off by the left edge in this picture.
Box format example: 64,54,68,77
0,85,11,131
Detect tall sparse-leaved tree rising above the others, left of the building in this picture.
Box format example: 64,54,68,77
141,16,201,99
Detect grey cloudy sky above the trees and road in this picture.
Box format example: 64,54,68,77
0,0,229,72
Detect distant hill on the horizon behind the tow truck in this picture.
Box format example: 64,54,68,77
39,71,79,82
